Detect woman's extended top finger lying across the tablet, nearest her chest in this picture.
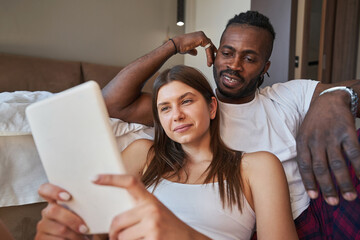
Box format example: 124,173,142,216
93,174,152,201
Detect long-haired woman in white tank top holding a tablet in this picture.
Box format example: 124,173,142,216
37,66,297,239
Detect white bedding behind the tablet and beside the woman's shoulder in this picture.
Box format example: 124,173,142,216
0,91,154,207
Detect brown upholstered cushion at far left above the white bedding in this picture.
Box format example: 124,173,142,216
0,53,82,92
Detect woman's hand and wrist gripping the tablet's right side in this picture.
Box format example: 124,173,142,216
94,175,209,240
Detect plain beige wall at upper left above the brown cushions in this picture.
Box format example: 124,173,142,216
0,0,184,68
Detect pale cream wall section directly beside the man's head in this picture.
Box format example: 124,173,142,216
185,0,251,86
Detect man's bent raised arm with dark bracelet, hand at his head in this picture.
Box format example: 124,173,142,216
103,32,216,125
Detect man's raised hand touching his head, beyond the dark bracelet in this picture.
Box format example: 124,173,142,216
173,31,217,67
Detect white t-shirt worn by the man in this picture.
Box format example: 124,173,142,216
219,80,318,219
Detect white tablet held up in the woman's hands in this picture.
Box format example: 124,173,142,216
26,81,133,234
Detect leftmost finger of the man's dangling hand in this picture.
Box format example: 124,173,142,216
296,138,319,199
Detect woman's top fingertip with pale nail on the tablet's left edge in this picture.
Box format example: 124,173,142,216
38,183,71,202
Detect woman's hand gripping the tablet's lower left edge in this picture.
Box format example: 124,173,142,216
35,183,88,240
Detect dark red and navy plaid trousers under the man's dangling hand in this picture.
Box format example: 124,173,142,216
251,130,360,240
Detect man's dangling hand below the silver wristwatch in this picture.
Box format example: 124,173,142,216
296,91,360,205
